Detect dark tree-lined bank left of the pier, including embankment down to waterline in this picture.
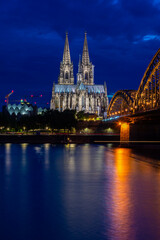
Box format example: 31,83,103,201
0,107,120,144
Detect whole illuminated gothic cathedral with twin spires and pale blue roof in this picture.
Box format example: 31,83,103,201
50,33,108,115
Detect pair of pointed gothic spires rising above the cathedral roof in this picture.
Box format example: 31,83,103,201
58,33,94,85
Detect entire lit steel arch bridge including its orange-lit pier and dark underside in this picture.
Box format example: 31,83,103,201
107,49,160,144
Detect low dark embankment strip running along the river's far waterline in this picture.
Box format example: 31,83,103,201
0,134,160,146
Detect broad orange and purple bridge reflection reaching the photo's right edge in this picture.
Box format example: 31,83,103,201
105,148,160,240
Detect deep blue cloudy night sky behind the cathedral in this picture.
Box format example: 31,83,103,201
0,0,160,106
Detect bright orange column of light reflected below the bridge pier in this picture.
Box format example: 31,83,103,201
106,148,135,240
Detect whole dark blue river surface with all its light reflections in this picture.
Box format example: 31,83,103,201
0,144,160,240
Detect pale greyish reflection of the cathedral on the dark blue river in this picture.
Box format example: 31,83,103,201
63,144,105,239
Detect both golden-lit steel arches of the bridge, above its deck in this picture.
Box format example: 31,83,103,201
107,49,160,117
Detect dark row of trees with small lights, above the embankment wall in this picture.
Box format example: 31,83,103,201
0,107,119,135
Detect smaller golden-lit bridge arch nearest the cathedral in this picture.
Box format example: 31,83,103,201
107,90,136,118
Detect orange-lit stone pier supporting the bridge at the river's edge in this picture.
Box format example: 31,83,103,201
120,123,130,146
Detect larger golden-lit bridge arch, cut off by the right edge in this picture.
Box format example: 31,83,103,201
133,49,160,112
